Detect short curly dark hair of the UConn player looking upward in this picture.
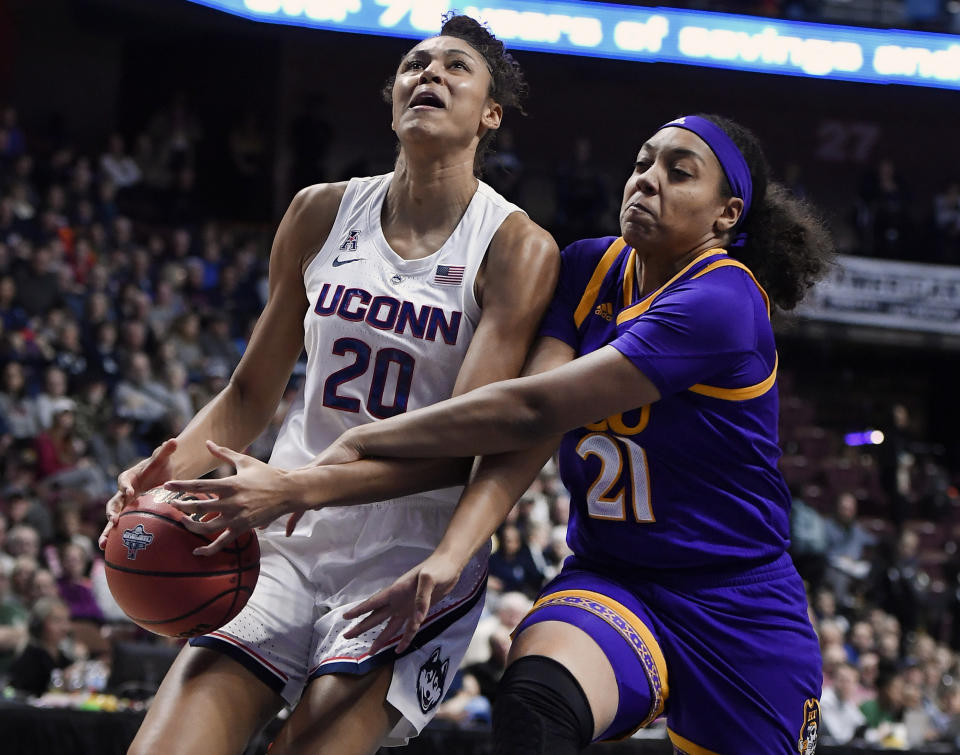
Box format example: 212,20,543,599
382,11,530,176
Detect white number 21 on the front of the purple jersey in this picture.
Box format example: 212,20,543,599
577,433,656,523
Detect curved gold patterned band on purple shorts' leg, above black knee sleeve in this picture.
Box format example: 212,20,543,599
527,590,670,738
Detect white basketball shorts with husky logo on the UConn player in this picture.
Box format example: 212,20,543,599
190,497,489,746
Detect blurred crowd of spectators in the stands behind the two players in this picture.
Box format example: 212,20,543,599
0,22,960,747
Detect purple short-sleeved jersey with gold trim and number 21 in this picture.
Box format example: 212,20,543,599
540,237,790,578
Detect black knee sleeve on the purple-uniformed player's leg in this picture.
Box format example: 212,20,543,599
493,655,593,755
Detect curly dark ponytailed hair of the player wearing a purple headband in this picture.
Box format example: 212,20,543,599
699,113,835,309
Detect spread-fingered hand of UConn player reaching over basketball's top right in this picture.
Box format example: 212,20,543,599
163,440,296,556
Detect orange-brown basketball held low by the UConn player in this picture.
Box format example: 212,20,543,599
104,488,260,637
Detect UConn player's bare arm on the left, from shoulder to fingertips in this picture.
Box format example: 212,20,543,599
100,184,343,547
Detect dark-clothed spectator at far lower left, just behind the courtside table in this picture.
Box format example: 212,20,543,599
10,598,76,697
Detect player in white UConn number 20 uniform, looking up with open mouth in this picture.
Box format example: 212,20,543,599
101,16,559,755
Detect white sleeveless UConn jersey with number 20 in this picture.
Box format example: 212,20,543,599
270,173,520,508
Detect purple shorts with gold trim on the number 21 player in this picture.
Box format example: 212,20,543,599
516,554,823,755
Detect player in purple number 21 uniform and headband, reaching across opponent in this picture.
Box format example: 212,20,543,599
304,116,832,755
